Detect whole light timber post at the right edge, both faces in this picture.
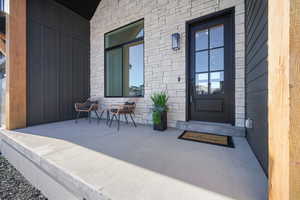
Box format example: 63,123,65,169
268,0,300,200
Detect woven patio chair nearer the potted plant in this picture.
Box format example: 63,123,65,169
109,102,136,131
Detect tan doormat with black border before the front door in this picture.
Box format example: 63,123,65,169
178,131,234,148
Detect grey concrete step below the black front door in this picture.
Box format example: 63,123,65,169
176,121,245,137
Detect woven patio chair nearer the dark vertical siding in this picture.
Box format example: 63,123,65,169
75,99,103,123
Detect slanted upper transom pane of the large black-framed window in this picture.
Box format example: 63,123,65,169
105,20,144,48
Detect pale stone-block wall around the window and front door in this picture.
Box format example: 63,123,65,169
91,0,245,126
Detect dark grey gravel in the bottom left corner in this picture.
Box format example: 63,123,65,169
0,155,47,200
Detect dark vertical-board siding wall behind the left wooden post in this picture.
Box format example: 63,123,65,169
27,0,90,125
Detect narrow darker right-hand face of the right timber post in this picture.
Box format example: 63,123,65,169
289,0,300,200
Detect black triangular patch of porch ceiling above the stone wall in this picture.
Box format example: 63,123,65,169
55,0,101,20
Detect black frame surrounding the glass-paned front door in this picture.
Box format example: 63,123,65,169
185,7,236,125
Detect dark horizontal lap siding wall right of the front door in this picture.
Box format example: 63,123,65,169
245,0,268,174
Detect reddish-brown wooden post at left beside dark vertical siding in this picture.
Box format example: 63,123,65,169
5,0,27,129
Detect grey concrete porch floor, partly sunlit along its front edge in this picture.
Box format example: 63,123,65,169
0,119,267,200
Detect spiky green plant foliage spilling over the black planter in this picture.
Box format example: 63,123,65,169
151,91,169,124
